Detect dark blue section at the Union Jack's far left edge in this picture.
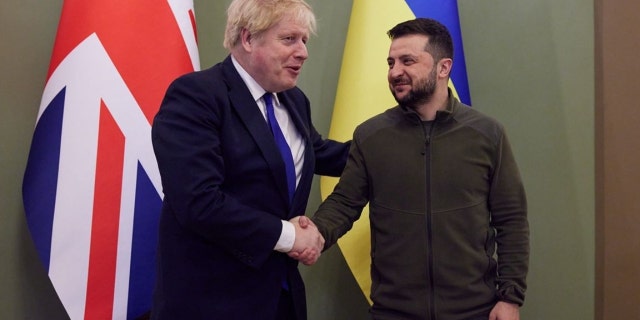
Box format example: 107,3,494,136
22,88,66,272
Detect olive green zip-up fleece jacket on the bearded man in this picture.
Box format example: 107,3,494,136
312,92,529,320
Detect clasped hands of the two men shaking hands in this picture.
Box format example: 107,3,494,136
287,216,324,266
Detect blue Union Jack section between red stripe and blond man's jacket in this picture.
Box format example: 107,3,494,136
127,163,162,319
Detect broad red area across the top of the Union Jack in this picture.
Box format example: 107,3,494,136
47,0,195,123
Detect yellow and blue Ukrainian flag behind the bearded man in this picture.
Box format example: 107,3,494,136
321,0,471,304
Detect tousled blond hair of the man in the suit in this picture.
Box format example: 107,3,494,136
223,0,316,50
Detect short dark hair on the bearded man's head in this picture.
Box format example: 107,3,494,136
387,18,453,61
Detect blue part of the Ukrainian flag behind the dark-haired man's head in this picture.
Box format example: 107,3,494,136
405,0,471,105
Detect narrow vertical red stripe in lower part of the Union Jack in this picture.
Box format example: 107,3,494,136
84,101,125,319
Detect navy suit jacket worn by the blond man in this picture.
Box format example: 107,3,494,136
152,57,349,320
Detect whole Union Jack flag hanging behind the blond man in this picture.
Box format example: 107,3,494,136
23,0,200,319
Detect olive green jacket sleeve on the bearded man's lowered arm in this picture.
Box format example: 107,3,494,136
489,132,529,305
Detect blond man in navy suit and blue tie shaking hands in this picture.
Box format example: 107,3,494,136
151,0,349,320
